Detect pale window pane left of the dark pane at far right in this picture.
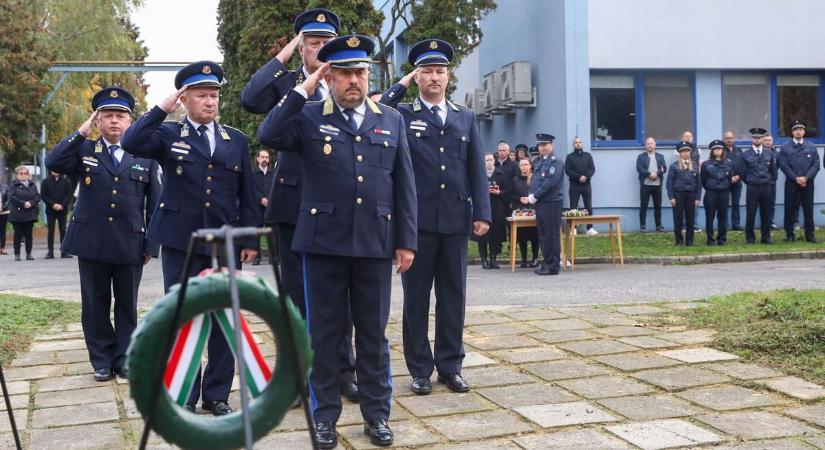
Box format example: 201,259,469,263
722,74,771,141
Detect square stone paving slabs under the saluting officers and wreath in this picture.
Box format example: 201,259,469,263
0,303,825,450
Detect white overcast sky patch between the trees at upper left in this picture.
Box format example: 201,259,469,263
132,0,223,108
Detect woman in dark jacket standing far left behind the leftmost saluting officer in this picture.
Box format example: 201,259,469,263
6,166,40,261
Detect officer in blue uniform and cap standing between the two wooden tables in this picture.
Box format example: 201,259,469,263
527,134,564,275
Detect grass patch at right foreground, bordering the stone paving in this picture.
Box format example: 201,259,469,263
660,289,825,384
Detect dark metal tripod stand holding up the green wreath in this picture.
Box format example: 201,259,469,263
137,225,318,450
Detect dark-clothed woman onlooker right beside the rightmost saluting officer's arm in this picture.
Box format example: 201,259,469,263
472,154,508,269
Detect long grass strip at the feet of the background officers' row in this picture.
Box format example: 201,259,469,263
468,228,825,260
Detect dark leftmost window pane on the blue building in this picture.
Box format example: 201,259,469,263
590,75,638,142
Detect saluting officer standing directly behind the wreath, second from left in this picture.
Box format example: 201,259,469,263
123,61,258,416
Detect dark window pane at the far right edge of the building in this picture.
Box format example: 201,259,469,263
776,75,822,137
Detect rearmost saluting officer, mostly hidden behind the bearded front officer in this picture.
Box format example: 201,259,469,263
241,8,358,402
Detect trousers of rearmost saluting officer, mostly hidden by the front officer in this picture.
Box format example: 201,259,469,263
278,223,355,384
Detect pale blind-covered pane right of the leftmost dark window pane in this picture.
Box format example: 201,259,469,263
643,75,694,142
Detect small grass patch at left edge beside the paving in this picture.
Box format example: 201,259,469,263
0,294,80,365
